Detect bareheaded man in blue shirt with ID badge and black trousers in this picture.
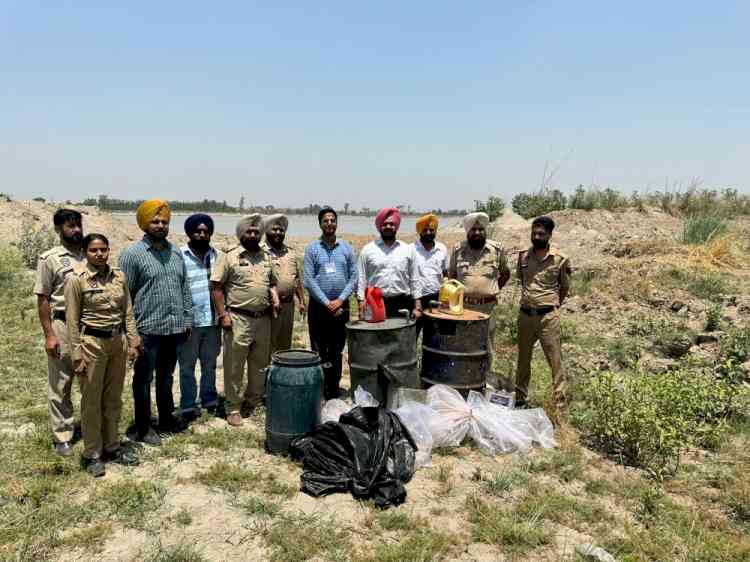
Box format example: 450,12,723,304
304,207,357,400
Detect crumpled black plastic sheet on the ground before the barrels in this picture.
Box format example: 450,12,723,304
291,406,417,508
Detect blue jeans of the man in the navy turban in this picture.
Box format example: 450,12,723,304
177,326,221,412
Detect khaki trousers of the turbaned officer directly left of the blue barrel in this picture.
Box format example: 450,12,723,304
224,311,271,414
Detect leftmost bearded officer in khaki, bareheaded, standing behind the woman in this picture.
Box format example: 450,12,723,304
34,209,85,457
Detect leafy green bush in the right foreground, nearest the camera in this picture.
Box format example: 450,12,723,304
573,370,734,479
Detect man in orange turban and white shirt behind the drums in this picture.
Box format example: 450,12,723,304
414,213,448,336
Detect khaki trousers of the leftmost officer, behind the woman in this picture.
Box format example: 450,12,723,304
47,320,73,443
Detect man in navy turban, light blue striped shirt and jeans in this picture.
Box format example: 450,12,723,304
177,213,223,422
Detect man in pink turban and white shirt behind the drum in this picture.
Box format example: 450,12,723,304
357,207,422,318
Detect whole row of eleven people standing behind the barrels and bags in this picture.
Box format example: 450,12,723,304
34,199,570,476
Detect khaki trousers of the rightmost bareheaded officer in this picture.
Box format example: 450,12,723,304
516,309,565,405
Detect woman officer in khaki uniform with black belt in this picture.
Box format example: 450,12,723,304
65,234,140,477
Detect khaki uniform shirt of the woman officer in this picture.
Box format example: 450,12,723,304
65,265,140,358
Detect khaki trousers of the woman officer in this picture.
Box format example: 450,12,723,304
78,334,128,459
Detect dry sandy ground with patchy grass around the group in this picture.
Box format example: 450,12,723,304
0,203,750,562
